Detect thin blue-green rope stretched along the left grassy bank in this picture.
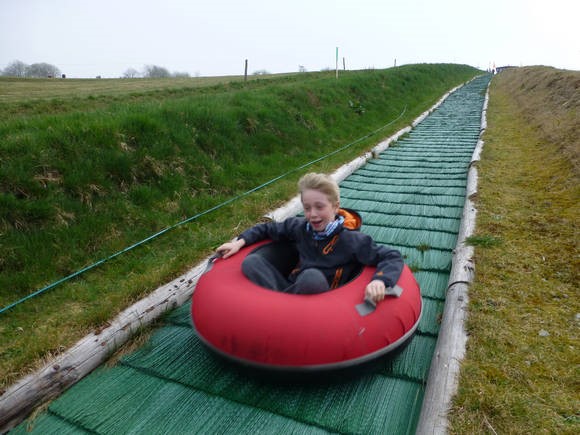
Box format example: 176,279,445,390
0,106,407,314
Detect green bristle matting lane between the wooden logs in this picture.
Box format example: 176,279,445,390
13,76,490,434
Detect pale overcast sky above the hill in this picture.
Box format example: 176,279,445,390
0,0,580,77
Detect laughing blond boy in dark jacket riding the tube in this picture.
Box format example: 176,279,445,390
216,173,403,302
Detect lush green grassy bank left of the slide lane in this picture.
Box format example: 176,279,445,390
0,65,477,386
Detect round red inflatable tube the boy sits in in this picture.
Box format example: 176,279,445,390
192,242,422,371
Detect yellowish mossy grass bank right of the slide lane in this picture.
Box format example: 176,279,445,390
451,67,580,434
